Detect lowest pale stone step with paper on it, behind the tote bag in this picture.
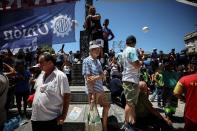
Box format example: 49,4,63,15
63,104,124,131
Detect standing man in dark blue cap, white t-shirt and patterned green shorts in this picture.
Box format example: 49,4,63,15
122,35,142,131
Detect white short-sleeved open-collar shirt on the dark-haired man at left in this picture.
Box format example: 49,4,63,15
31,68,70,121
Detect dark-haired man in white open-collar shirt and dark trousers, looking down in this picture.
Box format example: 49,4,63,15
31,52,70,131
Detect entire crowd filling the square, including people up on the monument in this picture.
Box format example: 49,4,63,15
0,6,197,131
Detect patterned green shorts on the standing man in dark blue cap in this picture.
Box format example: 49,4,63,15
123,81,140,105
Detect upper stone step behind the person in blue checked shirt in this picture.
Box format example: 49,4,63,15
70,86,111,104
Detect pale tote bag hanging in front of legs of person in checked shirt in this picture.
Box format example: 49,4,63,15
86,103,102,131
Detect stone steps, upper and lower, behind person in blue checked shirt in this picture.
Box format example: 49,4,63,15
63,86,124,131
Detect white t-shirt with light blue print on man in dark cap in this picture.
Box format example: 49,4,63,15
122,47,140,83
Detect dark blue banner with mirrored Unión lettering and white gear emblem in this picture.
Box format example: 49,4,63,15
0,2,75,49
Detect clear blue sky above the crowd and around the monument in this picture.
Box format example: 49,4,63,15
53,0,197,53
